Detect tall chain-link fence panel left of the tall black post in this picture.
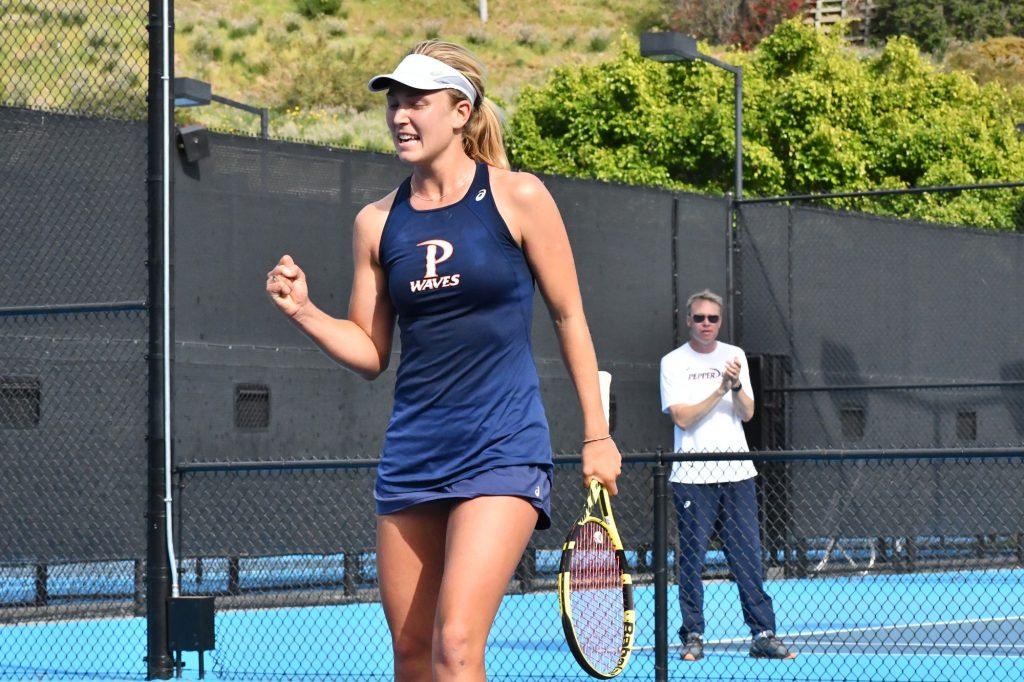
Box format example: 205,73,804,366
0,0,148,679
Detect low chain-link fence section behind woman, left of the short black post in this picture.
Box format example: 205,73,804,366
169,462,653,680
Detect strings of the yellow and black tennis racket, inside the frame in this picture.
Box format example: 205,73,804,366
569,521,624,671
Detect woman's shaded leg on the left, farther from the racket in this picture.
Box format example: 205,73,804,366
377,502,452,682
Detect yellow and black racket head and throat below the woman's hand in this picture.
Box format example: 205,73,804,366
558,481,635,680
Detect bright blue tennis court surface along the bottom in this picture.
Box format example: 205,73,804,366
0,569,1024,682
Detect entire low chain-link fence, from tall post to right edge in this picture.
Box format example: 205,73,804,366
149,451,1024,681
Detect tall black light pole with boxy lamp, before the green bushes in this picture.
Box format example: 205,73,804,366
640,32,743,343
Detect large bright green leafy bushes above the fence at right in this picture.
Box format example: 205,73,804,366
509,19,1024,228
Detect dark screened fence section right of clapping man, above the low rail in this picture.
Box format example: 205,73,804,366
736,196,1024,449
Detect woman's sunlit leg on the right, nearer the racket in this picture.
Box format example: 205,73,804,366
433,497,538,682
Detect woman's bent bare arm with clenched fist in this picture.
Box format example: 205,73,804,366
266,200,394,380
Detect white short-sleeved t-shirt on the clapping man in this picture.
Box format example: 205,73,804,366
662,341,758,483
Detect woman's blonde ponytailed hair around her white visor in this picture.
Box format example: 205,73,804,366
410,40,509,169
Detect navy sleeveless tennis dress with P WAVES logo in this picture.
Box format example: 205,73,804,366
375,163,552,528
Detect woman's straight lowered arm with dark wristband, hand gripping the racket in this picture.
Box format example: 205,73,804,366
492,167,622,495
